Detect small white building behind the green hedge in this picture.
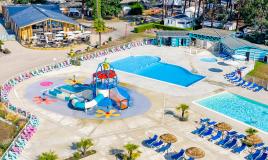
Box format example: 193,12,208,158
164,14,194,28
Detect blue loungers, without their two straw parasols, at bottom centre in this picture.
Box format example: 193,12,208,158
143,135,194,160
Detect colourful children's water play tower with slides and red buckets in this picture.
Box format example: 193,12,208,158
43,59,130,111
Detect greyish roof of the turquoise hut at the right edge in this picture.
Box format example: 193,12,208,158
221,36,268,51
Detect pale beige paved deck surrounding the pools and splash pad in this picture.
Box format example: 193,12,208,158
9,46,268,160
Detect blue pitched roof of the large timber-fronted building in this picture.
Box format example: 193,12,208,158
11,5,78,27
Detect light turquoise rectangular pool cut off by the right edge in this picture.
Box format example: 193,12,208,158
196,92,268,132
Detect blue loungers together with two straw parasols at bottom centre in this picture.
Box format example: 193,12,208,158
143,133,205,160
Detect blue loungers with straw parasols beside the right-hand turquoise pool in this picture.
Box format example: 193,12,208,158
191,118,268,160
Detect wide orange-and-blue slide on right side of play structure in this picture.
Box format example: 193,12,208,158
110,87,128,109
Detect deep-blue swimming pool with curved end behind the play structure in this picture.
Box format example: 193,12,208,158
111,56,204,87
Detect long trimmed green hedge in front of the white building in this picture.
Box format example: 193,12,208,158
134,23,193,33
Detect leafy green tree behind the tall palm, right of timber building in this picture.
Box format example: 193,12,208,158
87,0,122,18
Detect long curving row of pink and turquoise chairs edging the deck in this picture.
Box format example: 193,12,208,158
0,40,151,160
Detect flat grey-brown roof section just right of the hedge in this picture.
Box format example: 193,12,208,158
190,28,233,38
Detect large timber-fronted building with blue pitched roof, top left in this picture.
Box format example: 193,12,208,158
3,5,80,40
